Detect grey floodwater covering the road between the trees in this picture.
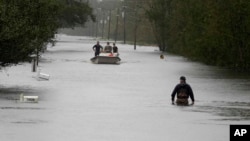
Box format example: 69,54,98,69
0,35,250,141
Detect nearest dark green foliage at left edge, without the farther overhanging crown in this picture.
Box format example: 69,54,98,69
0,0,59,66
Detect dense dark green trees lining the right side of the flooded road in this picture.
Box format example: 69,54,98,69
146,0,250,70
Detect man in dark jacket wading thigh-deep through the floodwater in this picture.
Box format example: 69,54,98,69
171,76,194,106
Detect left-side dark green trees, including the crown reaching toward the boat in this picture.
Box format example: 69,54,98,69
0,0,94,68
